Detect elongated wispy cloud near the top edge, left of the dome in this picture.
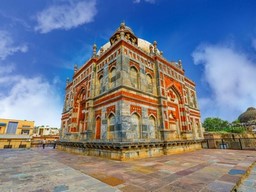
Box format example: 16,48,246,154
35,0,97,33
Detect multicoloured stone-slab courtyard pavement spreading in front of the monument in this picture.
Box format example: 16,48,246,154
0,148,256,192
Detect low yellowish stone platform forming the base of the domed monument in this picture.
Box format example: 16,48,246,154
58,139,202,161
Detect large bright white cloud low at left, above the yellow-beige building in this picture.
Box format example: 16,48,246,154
0,66,62,127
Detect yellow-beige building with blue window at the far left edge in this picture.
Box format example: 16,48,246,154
0,118,34,149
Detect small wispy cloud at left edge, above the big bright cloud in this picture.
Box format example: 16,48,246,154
0,30,28,60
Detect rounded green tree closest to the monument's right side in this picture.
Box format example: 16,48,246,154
203,117,229,131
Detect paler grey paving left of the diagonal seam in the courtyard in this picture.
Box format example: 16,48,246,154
0,148,119,192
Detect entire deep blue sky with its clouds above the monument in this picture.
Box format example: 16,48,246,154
0,0,256,127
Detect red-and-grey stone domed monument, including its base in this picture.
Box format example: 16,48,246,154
61,23,203,159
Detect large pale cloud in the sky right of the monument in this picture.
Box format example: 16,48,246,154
192,45,256,121
